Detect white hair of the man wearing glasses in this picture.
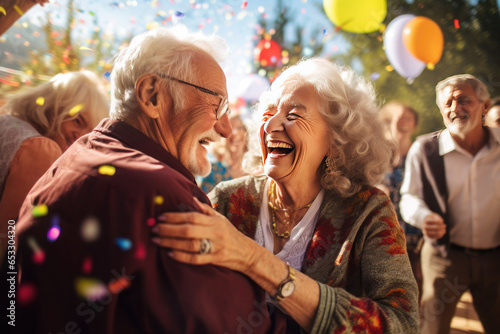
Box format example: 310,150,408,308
110,24,229,120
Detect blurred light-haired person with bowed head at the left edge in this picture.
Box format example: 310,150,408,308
0,71,109,263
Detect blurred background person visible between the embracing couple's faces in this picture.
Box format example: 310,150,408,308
197,113,248,193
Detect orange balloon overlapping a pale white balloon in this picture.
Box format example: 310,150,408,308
403,16,444,65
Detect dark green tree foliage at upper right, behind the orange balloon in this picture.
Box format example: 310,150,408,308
334,0,500,134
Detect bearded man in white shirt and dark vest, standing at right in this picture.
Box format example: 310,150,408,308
400,74,500,334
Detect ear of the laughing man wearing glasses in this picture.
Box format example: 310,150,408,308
135,73,168,119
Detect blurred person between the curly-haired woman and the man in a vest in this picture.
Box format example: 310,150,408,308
379,101,423,298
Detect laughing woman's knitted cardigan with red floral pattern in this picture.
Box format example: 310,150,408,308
209,176,418,334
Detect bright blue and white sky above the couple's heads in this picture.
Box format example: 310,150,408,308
0,0,346,95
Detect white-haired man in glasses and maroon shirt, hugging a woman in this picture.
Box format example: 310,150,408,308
11,26,283,333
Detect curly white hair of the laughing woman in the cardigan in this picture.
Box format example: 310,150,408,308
249,58,394,197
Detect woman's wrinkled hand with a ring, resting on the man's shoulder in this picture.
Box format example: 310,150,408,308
152,198,257,272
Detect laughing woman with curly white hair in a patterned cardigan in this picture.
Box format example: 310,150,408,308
153,58,418,333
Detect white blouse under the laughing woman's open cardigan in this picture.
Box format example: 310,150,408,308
255,179,325,271
